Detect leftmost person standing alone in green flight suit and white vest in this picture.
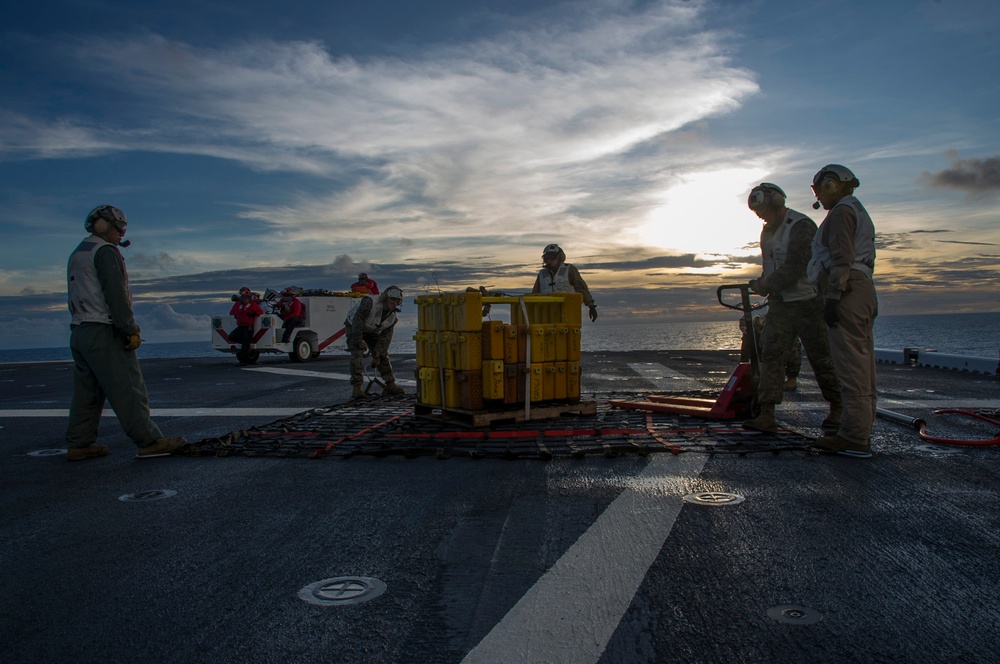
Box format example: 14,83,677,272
66,205,186,461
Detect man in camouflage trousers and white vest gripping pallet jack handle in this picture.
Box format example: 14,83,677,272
743,182,843,433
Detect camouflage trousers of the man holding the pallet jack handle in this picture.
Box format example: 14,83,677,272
757,297,841,404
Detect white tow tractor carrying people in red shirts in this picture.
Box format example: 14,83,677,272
212,288,364,364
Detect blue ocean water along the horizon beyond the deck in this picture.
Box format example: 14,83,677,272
0,312,1000,362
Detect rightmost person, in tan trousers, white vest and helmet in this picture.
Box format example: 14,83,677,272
808,164,878,457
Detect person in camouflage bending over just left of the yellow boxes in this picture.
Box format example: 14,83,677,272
344,286,404,399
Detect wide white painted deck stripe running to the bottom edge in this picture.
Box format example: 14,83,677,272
462,455,707,664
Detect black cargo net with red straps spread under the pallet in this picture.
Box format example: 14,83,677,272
180,395,814,460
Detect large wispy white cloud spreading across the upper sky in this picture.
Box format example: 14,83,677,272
9,0,758,262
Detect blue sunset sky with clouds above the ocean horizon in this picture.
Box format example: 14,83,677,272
0,0,1000,348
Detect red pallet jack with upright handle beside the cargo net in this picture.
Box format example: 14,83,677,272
609,284,767,420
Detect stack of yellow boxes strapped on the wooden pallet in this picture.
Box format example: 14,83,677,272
413,291,583,410
